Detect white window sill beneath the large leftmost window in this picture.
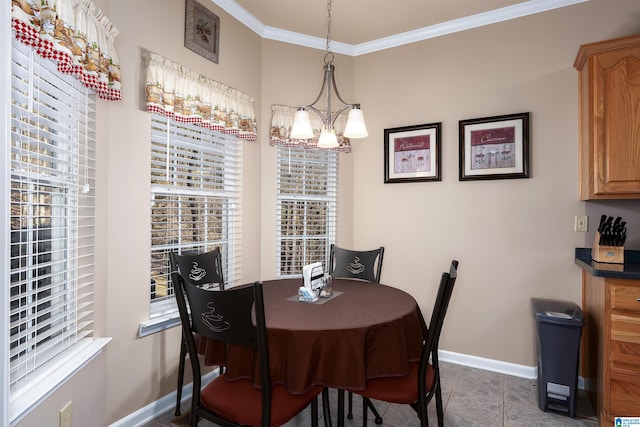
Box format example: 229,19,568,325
9,338,111,426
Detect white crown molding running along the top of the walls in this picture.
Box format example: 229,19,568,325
211,0,589,56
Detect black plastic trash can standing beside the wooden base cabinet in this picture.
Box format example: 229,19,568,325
531,298,584,418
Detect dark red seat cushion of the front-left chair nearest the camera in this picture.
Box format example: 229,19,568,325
200,375,322,426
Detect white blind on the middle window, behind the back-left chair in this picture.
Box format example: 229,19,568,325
150,114,242,317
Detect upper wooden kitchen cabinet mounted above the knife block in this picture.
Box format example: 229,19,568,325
573,34,640,200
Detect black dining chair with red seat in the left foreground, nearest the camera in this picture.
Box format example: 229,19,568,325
170,260,324,427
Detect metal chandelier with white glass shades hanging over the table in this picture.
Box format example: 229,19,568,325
291,0,369,148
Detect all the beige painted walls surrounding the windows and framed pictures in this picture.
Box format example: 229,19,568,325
13,0,640,427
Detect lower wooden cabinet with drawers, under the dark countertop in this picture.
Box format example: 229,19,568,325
582,272,640,426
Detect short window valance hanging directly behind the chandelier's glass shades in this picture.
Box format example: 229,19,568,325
271,105,351,153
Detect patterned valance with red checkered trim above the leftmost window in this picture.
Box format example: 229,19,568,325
11,0,122,100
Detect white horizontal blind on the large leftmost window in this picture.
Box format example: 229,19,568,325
9,40,96,400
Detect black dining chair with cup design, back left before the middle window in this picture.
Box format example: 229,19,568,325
169,248,225,416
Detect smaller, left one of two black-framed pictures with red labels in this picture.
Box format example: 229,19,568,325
384,122,442,184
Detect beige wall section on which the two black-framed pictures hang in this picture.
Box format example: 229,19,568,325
353,0,640,366
